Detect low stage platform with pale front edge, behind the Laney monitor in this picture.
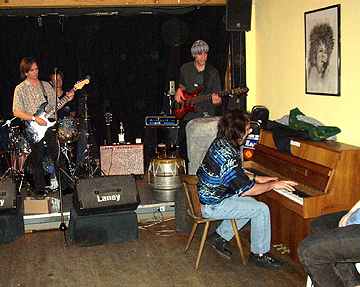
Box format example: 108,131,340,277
24,175,175,232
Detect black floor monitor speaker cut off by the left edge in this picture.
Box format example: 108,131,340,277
0,178,21,214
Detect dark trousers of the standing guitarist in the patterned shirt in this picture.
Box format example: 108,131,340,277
30,128,59,193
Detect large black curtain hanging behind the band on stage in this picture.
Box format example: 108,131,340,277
0,6,230,145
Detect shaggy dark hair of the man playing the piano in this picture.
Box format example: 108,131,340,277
216,108,250,149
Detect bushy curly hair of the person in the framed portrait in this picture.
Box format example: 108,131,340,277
309,23,334,66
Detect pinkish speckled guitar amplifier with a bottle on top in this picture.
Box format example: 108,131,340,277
100,144,144,175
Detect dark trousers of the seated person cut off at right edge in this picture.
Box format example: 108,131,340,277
298,211,360,287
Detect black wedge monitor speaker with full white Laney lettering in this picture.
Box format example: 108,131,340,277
73,175,140,215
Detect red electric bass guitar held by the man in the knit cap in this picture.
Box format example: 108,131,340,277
174,87,249,120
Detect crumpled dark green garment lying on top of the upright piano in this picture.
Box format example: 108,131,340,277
289,108,341,141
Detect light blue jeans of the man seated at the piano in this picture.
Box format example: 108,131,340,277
201,195,271,254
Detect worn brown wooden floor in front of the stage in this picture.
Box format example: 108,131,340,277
0,177,306,287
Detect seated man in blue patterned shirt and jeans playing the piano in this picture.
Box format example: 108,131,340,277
197,109,297,270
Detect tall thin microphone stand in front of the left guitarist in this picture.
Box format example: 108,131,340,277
54,67,69,247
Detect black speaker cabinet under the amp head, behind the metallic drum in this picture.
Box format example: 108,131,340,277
144,126,179,173
